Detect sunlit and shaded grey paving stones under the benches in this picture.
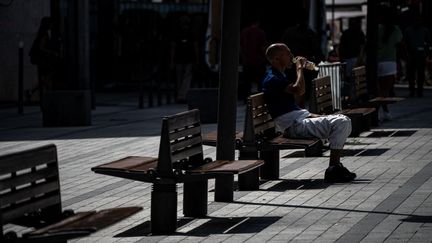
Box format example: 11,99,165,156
0,89,432,242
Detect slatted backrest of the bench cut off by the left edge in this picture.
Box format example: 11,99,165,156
0,144,62,234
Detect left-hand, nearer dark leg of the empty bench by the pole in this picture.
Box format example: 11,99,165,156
150,184,177,234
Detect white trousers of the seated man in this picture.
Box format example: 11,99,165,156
285,114,351,149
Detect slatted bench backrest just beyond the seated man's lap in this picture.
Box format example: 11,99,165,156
309,76,333,114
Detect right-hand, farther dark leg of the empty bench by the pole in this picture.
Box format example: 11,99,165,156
183,180,208,217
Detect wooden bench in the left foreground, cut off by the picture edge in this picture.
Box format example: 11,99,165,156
0,144,142,242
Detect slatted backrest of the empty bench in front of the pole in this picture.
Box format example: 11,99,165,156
157,109,204,177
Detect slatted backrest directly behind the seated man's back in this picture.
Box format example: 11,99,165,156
243,93,276,143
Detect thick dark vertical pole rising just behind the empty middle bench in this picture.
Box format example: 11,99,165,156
215,0,241,202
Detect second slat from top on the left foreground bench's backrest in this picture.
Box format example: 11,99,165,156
0,167,58,191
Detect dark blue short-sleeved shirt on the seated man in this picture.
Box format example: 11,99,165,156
262,68,301,119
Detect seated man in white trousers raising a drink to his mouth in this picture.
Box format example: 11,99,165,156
263,43,356,182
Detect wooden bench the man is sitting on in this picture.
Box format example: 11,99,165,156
203,93,322,179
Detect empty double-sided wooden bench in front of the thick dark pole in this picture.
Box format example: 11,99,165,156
92,110,264,234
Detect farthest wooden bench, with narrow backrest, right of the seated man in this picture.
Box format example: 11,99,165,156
349,66,405,125
